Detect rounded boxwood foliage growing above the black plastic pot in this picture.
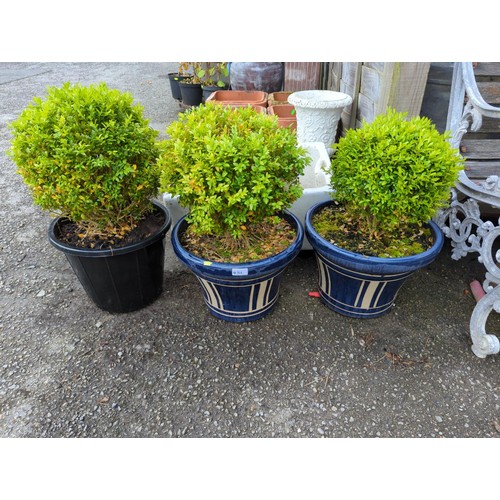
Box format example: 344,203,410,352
10,83,159,235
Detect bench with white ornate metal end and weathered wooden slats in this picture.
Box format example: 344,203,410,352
436,63,500,358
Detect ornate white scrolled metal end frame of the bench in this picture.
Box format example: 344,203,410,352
435,63,500,358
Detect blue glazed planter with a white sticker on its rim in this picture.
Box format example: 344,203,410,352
172,212,304,323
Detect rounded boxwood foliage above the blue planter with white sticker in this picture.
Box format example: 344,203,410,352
159,102,309,238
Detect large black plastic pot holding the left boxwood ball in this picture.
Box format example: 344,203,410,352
48,202,171,313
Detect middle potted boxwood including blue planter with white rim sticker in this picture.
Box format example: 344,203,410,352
159,102,309,322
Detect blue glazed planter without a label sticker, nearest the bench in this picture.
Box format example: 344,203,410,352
305,201,444,318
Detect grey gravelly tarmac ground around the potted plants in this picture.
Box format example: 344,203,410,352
0,63,500,444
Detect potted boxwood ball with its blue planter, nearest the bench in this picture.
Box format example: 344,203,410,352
305,110,463,318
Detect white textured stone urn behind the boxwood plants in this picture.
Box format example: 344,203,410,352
288,90,352,155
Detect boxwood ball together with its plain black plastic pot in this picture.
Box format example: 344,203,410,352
10,82,170,312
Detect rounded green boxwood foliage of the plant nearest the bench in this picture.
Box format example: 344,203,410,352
331,110,463,240
